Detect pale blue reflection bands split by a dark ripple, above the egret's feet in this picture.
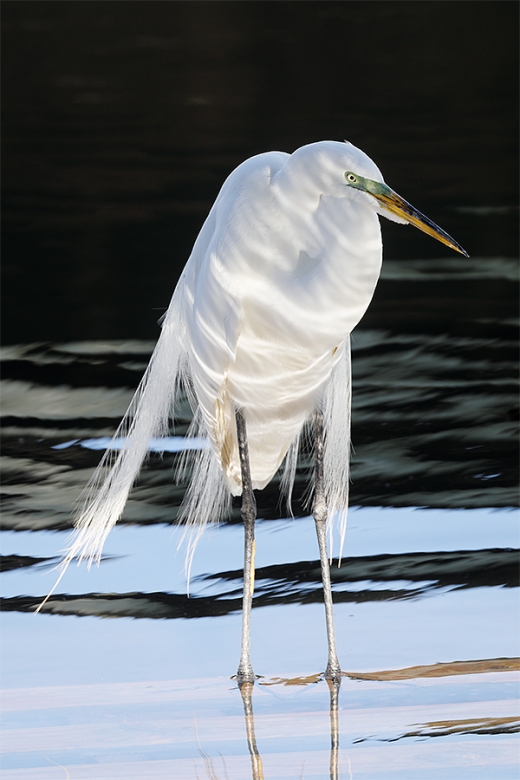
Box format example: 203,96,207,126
2,508,520,687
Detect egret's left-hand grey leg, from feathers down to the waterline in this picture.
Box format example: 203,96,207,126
235,410,256,688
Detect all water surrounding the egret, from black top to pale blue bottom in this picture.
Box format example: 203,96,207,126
1,2,520,780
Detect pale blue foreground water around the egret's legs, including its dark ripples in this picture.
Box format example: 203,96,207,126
2,507,520,780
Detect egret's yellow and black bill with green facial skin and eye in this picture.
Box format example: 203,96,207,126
344,171,469,257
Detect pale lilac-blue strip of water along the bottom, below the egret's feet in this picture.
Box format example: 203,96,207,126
4,670,518,780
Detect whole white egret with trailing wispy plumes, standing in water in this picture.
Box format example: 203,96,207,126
40,141,466,685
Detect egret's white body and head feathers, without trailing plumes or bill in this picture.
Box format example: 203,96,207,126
185,142,381,495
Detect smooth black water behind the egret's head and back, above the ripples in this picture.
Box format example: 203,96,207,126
2,0,518,344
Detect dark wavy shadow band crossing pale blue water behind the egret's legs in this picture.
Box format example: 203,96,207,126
0,549,519,619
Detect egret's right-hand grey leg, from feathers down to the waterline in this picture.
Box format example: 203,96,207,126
312,412,341,683
